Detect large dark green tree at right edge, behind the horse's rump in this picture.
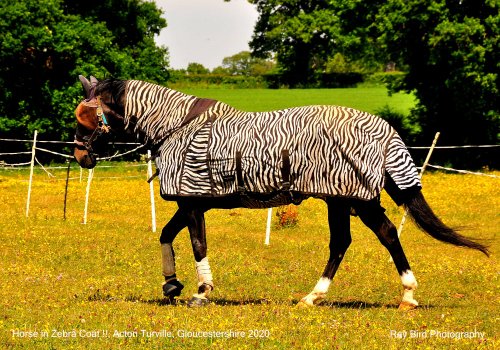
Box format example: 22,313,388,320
373,0,500,145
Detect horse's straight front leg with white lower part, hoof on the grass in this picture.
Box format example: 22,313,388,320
188,209,214,306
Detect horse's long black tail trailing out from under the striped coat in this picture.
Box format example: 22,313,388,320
385,176,489,256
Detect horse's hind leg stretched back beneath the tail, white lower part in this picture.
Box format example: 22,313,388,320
355,200,418,309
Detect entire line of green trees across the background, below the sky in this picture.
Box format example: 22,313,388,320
0,0,500,167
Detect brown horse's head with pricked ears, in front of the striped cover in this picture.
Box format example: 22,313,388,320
74,75,123,169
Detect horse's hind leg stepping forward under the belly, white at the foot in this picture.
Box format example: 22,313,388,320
299,198,351,306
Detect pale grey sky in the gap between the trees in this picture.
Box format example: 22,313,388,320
155,0,258,69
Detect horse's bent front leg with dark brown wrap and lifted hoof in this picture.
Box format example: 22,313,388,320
160,209,188,302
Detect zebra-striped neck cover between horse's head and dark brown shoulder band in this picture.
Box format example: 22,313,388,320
125,80,196,143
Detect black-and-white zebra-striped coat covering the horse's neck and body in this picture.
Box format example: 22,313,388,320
125,81,420,200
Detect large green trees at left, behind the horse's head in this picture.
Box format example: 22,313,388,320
0,0,168,140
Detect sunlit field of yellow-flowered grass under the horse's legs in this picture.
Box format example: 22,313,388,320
0,164,500,349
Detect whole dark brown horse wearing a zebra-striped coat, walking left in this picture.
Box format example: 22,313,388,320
74,76,489,310
